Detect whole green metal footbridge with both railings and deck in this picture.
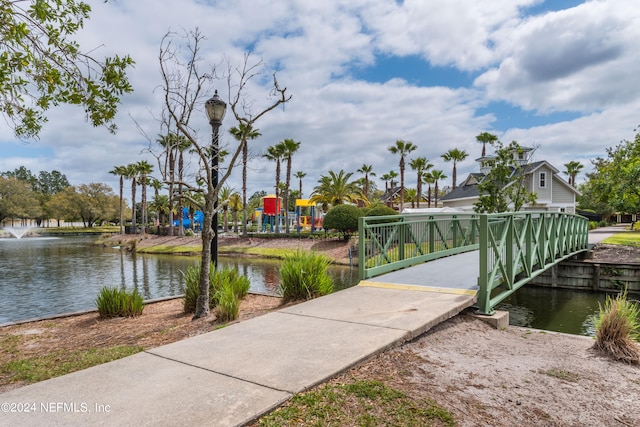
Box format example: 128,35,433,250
358,212,588,315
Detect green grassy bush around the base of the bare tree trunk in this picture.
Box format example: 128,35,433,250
182,264,251,321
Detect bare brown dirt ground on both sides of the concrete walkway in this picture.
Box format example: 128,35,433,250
0,236,640,426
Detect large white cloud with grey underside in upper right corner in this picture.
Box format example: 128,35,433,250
476,0,640,113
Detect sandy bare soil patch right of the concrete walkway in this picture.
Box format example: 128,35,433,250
333,314,640,427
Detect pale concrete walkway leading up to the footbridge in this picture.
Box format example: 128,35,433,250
0,286,475,426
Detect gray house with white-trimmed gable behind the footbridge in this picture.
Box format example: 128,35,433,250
441,147,580,213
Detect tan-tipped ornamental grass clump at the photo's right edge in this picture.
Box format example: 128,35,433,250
593,289,640,365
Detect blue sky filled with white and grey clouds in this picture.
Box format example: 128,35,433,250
0,0,640,202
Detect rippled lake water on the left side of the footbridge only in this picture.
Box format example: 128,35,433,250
0,237,358,324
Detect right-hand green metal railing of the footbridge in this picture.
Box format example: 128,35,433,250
478,212,589,314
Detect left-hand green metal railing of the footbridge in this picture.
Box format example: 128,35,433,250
358,213,480,280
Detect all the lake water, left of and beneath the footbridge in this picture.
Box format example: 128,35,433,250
0,237,620,336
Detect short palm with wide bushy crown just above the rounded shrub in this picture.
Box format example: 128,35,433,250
311,170,369,210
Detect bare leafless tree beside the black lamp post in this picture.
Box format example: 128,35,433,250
159,29,291,319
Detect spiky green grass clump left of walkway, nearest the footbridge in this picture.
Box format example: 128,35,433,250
280,251,333,303
